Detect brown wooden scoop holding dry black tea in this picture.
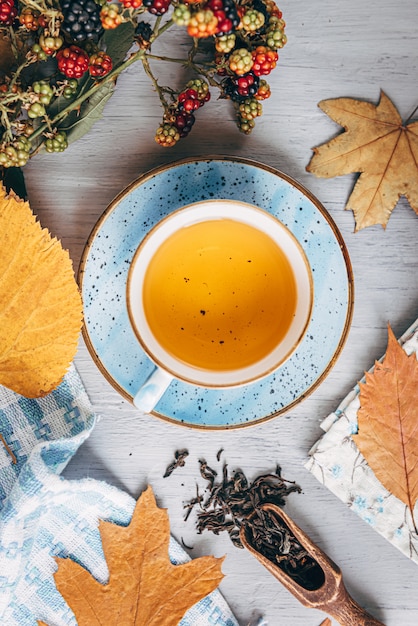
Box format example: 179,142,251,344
240,504,384,626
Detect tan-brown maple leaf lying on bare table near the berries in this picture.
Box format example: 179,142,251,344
306,92,418,231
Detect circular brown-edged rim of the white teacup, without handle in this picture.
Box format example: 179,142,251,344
126,198,314,389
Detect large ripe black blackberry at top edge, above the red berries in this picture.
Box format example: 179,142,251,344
61,0,103,43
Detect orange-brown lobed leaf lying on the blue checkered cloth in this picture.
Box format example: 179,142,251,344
38,487,223,626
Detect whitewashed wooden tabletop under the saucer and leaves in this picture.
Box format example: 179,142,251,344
25,0,418,626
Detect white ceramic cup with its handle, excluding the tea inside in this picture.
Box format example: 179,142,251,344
126,200,313,412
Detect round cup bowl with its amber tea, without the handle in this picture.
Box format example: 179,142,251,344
127,200,313,408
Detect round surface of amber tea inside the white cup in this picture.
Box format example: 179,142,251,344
143,219,297,371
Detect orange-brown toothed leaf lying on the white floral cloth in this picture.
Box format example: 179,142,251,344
353,326,418,518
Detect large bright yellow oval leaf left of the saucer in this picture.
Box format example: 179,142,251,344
0,185,82,398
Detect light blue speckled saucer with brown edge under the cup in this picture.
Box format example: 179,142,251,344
79,157,353,428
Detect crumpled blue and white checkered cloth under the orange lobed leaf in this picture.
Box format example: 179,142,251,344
0,366,238,626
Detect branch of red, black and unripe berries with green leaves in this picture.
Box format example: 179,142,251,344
0,0,286,168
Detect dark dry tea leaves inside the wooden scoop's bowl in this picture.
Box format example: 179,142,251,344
243,509,325,591
